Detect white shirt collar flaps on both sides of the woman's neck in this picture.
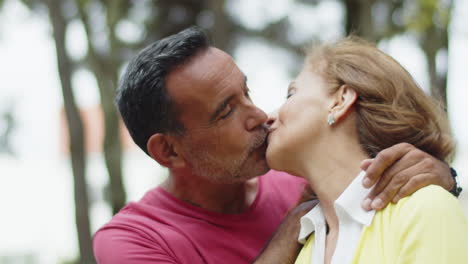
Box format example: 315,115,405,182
298,171,375,243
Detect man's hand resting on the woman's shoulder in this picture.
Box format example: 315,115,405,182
361,143,454,210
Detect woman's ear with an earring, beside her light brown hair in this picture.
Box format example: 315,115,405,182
330,84,358,122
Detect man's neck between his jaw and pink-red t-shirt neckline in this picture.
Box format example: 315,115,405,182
161,173,258,214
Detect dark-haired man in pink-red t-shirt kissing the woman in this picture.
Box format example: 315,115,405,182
94,28,453,263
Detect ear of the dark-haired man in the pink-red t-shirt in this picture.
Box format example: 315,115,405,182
146,133,186,169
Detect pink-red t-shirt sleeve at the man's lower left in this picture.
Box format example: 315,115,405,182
93,228,178,264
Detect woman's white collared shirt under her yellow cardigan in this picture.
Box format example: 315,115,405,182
298,171,375,264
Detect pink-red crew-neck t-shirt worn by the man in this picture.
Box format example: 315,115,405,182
94,171,305,264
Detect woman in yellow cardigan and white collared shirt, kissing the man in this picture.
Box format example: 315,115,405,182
267,38,468,264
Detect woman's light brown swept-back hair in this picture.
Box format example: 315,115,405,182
306,37,454,161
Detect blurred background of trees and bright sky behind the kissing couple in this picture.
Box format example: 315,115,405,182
0,0,468,264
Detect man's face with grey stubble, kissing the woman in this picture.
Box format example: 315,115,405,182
166,47,268,183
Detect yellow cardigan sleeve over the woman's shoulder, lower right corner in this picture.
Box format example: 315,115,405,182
395,186,468,264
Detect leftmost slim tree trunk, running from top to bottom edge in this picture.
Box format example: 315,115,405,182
47,0,95,263
